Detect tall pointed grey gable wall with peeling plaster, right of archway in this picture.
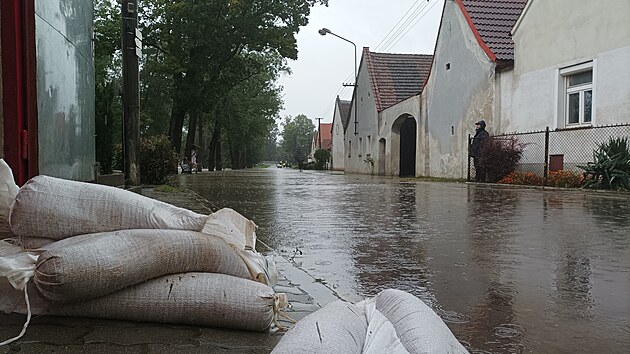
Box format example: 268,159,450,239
424,1,495,178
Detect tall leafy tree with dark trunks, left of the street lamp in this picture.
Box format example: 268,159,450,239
145,0,327,156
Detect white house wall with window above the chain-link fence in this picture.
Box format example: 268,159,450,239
504,0,630,132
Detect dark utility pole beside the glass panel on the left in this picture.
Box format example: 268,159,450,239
121,0,142,185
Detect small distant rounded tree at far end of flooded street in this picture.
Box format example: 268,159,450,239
282,114,315,164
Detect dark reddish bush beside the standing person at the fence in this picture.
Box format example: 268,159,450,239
479,136,525,182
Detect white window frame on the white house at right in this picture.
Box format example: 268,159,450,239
557,60,597,128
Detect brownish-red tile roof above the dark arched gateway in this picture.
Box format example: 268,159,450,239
363,48,433,112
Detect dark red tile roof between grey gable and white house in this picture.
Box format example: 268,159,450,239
457,0,527,60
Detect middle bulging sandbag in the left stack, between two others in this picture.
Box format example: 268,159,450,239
33,230,252,302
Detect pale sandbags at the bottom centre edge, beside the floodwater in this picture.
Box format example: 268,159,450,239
272,289,468,354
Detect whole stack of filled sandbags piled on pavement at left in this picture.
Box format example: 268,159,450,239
0,160,286,346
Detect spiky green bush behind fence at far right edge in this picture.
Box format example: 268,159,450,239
578,138,630,190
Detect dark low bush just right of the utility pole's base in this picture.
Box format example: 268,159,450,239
139,135,178,184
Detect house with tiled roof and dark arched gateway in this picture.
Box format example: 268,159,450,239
344,48,432,176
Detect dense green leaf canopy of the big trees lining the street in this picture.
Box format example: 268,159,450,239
141,0,327,155
